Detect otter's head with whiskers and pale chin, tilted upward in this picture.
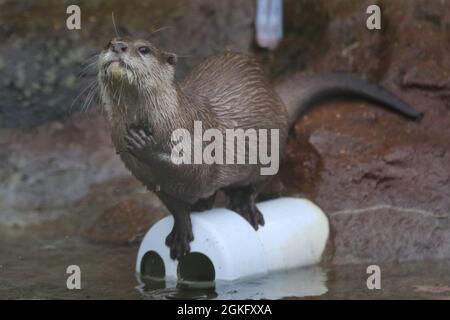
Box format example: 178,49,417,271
98,39,177,94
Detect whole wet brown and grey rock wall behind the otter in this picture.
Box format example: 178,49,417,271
0,0,450,264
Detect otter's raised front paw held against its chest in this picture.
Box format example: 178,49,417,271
124,125,156,161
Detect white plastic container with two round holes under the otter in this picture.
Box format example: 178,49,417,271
136,198,329,281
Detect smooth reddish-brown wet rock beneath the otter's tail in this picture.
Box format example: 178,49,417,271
284,93,450,264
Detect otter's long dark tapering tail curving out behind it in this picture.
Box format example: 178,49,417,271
276,73,422,125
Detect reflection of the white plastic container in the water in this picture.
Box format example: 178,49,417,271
137,266,328,300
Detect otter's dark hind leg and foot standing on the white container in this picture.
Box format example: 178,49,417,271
224,184,264,230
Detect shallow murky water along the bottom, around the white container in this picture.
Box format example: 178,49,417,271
0,238,450,299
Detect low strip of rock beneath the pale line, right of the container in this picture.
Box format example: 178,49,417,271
331,205,450,264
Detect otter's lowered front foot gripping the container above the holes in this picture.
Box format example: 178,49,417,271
166,217,194,260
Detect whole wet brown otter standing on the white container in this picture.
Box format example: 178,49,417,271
98,38,421,259
